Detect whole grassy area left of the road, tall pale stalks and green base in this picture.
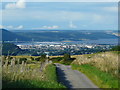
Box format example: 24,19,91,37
2,58,64,88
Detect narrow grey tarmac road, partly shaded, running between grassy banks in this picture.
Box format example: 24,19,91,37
55,63,98,88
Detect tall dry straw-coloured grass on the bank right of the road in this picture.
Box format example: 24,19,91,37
72,52,120,78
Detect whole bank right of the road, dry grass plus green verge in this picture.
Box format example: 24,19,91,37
71,51,120,88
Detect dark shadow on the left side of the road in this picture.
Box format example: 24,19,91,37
56,67,72,88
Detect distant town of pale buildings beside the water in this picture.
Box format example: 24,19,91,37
17,42,114,56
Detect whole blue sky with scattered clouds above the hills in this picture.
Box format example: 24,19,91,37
0,0,118,30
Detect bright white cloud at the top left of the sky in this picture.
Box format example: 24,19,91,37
5,0,26,9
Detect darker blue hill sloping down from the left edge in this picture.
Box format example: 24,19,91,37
0,29,30,41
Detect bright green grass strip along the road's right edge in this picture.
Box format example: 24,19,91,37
72,64,118,88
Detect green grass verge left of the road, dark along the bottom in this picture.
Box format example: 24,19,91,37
2,64,65,88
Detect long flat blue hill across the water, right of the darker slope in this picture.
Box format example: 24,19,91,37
16,30,117,41
